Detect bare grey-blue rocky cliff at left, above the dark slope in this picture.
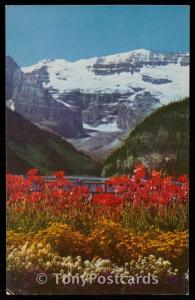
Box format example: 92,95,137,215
6,57,86,137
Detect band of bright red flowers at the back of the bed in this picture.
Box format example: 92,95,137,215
7,165,189,213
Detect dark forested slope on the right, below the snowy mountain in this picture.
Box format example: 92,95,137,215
103,98,189,176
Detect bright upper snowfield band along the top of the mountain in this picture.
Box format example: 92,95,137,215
22,49,189,103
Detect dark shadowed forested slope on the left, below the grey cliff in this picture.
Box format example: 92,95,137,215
6,109,100,175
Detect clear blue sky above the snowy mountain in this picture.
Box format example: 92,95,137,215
6,5,189,66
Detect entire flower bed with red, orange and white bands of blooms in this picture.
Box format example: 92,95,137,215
7,165,189,293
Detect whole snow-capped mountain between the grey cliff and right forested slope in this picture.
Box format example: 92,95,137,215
6,49,189,159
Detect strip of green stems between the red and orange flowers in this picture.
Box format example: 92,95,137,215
7,203,189,234
